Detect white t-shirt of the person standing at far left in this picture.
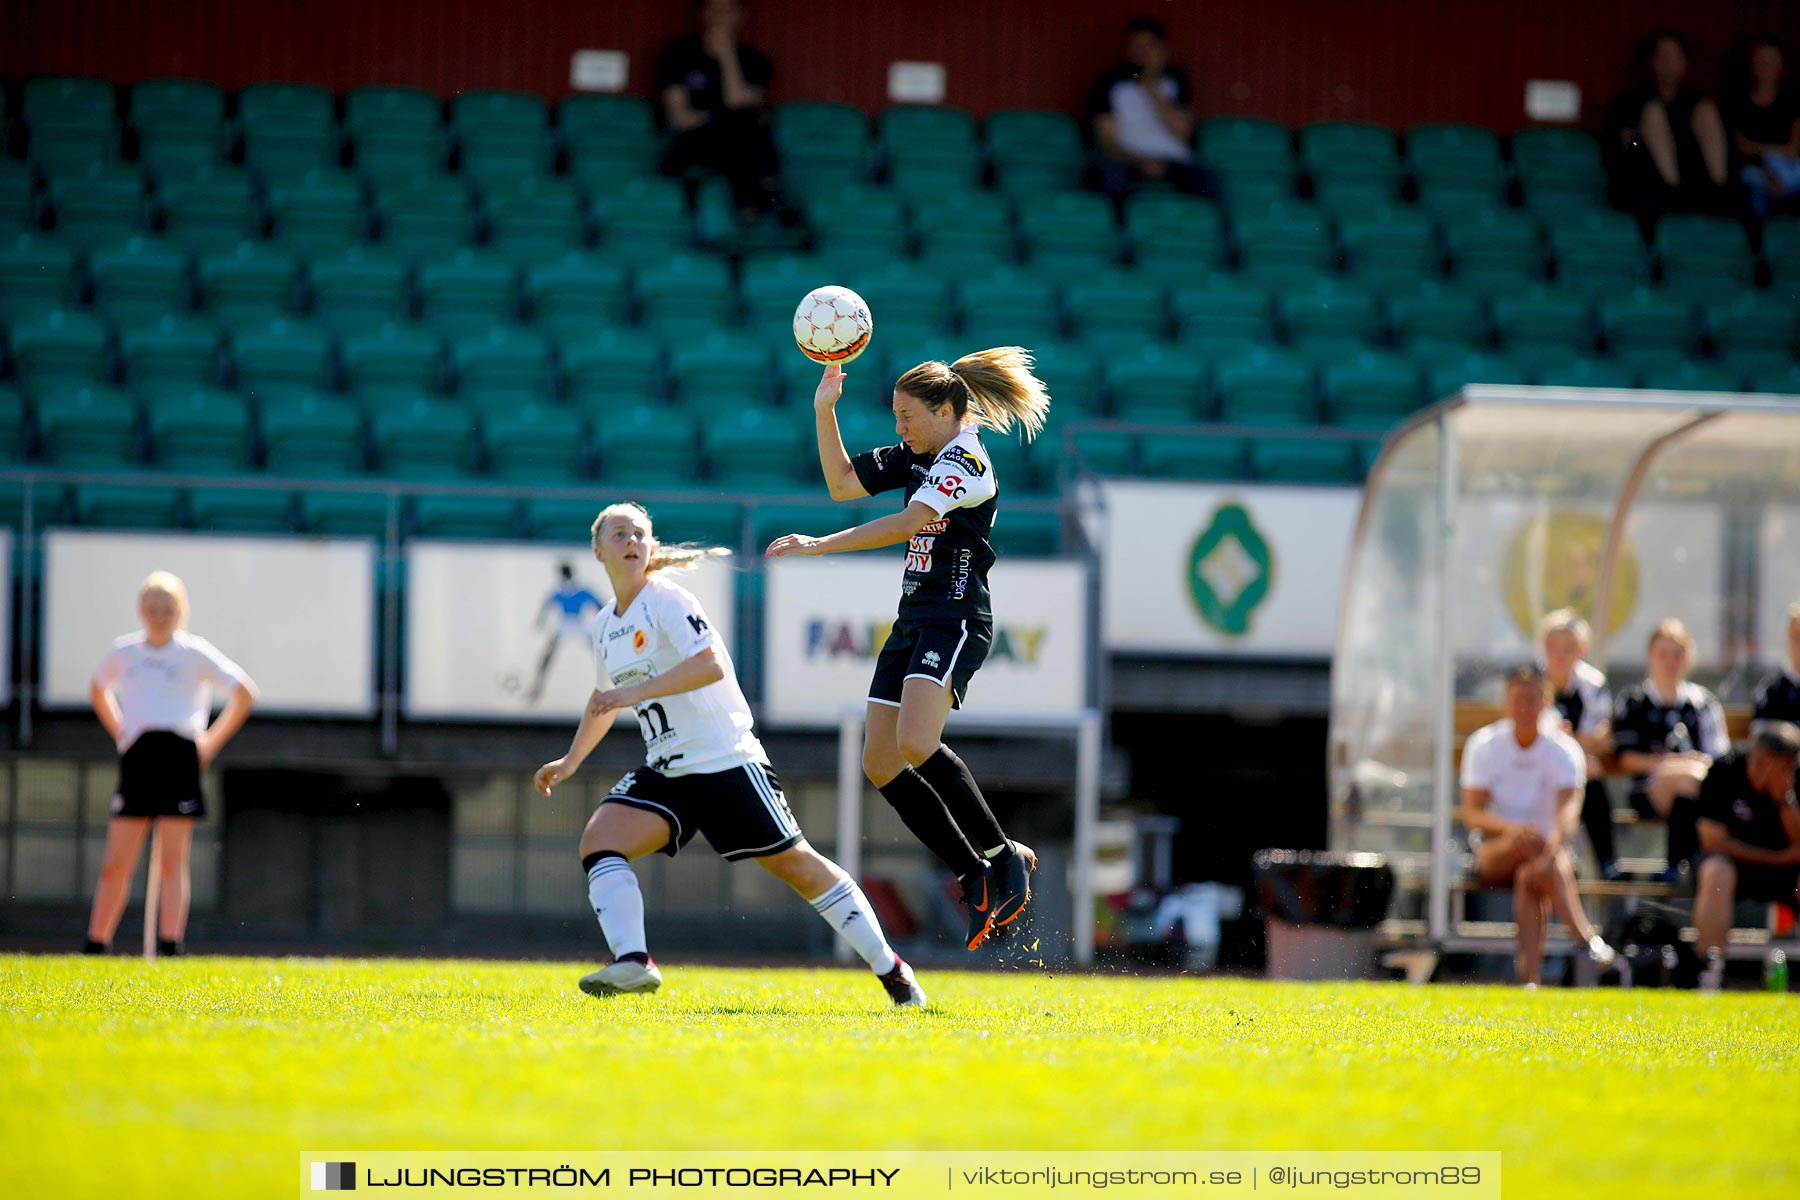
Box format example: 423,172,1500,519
94,630,250,754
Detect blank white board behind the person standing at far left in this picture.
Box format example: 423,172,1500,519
43,529,374,716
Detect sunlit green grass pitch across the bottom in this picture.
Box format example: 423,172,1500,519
0,955,1800,1200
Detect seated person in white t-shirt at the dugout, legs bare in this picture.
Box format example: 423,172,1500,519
1462,667,1618,986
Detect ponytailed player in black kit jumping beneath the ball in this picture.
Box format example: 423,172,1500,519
767,345,1049,950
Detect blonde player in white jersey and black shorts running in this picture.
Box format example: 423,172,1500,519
533,504,925,1006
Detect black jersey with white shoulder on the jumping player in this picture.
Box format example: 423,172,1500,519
850,428,999,624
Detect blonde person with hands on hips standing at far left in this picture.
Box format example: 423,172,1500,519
86,570,256,955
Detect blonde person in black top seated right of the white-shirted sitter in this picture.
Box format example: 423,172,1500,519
1613,619,1732,883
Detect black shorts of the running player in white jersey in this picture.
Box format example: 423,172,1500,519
601,763,801,862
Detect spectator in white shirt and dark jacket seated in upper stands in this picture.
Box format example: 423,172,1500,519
1087,16,1219,203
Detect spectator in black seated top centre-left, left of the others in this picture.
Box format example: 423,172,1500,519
657,0,781,221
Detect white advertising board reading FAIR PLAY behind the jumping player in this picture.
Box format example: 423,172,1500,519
758,554,1087,727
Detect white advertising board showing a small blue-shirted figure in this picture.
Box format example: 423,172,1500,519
405,540,736,721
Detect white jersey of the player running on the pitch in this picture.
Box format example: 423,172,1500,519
592,576,769,775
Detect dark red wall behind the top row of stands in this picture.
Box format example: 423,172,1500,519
10,0,1800,128
